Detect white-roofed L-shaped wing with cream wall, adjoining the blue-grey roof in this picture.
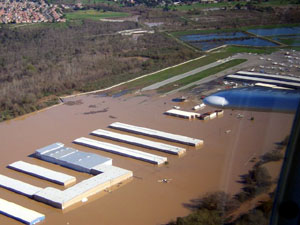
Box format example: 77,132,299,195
0,167,133,209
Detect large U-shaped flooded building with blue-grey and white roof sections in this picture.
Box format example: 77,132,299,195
0,143,133,209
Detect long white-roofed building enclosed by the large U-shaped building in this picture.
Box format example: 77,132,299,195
8,161,76,186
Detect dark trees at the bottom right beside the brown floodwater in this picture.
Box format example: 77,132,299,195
167,136,289,225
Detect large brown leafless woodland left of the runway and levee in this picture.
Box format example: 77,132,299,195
0,20,199,120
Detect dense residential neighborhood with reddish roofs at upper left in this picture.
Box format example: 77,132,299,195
0,0,65,23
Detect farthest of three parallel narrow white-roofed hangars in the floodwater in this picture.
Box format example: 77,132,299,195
109,122,203,147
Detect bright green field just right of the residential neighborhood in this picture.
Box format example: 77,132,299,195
65,10,129,20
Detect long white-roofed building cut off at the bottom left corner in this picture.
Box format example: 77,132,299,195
0,198,45,225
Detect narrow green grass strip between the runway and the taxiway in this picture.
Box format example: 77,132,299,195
158,59,247,93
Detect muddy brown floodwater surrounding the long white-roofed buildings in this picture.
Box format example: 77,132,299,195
0,92,293,225
